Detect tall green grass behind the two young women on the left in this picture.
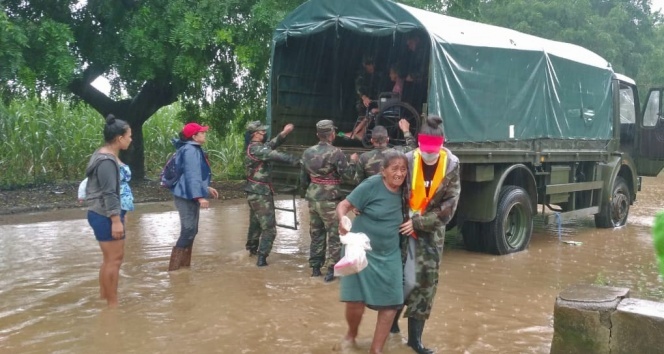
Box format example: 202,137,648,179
0,99,244,188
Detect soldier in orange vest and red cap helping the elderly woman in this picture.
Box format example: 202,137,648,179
395,116,461,354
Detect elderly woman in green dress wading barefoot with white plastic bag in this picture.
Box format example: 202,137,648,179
336,151,408,353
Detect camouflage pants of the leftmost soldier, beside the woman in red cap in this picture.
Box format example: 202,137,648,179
245,193,277,257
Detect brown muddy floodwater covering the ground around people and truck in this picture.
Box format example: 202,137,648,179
0,177,664,353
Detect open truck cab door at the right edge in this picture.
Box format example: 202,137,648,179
636,88,664,177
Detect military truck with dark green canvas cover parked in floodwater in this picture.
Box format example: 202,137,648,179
268,0,664,255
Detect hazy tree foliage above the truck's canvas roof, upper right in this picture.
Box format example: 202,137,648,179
480,0,664,90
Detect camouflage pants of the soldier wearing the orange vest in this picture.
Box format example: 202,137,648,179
404,231,445,320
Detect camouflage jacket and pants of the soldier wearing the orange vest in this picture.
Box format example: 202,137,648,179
404,149,461,320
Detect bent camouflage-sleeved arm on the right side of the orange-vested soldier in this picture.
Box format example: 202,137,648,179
413,164,461,232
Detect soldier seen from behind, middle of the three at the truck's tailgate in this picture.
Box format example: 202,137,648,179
300,120,357,282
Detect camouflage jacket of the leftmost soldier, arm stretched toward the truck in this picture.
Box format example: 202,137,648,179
244,135,299,195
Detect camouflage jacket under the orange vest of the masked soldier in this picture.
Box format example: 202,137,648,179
404,148,461,252
